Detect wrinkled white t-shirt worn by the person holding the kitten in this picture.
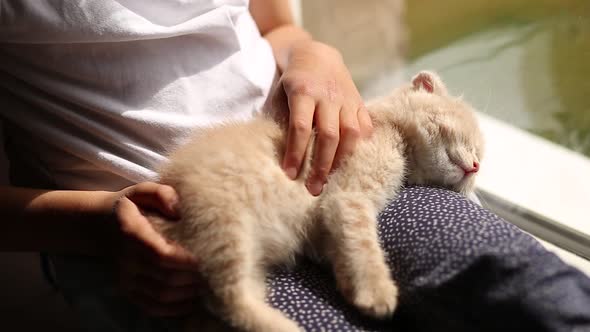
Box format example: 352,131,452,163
0,0,276,190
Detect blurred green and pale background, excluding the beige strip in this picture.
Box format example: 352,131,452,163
406,0,590,156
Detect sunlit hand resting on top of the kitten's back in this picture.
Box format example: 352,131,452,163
274,41,372,195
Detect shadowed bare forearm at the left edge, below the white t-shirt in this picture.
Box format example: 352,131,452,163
0,186,115,254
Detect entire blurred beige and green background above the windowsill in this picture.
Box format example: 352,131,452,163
302,0,590,156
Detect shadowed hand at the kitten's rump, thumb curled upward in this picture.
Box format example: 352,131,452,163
107,182,199,316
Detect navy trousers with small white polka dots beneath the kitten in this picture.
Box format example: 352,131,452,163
268,187,590,331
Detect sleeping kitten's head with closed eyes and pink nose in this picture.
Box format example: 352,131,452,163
401,71,484,195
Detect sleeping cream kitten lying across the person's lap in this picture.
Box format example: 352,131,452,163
152,72,483,332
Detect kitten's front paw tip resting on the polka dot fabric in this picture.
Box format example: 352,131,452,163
353,279,398,319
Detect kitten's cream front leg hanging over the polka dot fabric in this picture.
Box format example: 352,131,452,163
322,193,398,318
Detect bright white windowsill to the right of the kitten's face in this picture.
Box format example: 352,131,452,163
478,114,590,263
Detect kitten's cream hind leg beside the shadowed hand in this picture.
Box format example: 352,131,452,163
199,216,301,332
